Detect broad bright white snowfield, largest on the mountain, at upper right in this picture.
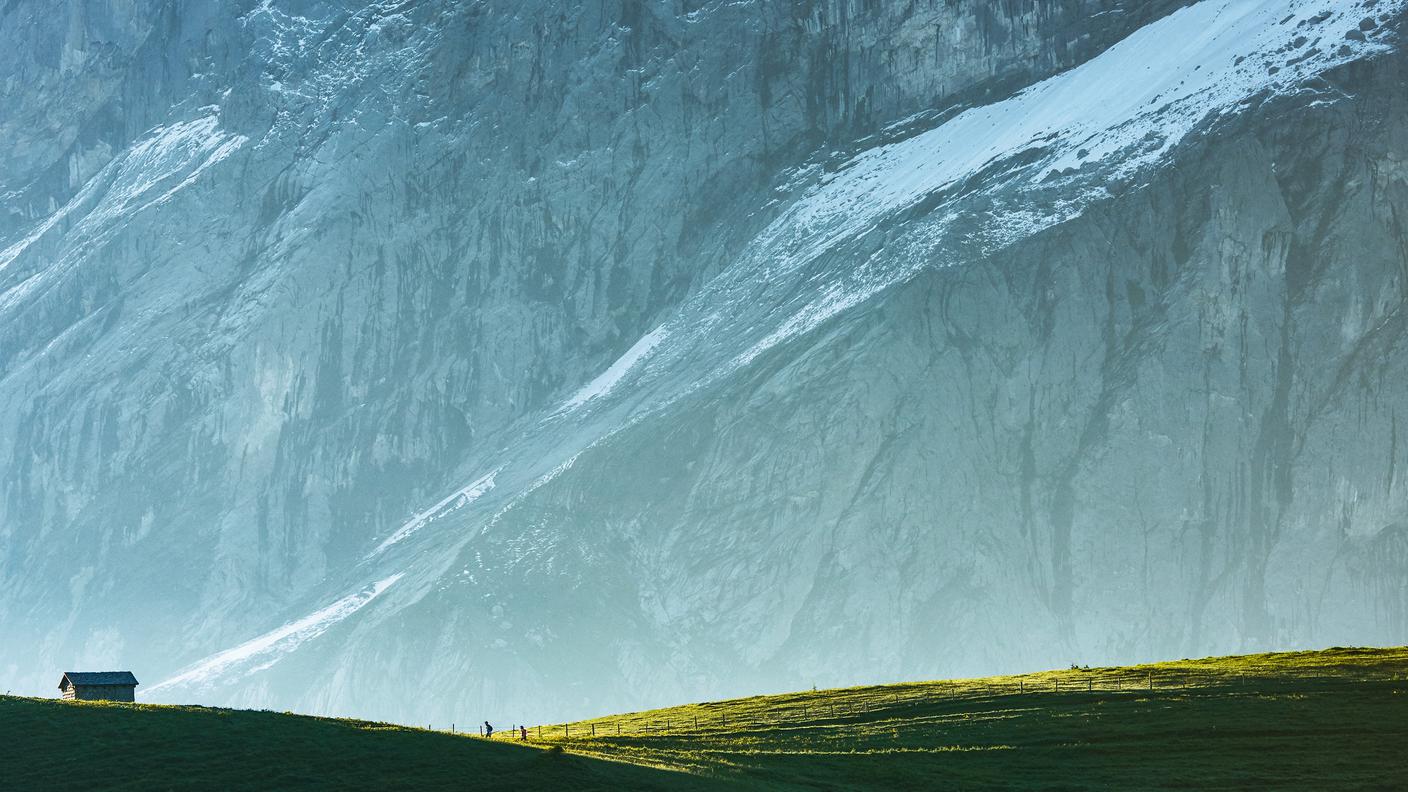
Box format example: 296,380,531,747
794,0,1402,240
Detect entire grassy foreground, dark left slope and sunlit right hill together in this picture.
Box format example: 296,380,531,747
11,648,1408,789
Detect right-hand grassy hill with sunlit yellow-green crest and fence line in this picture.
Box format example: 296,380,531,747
509,648,1408,788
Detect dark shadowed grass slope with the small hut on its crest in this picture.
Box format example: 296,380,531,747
0,696,717,792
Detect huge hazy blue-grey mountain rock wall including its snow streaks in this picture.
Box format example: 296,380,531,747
0,0,1408,722
